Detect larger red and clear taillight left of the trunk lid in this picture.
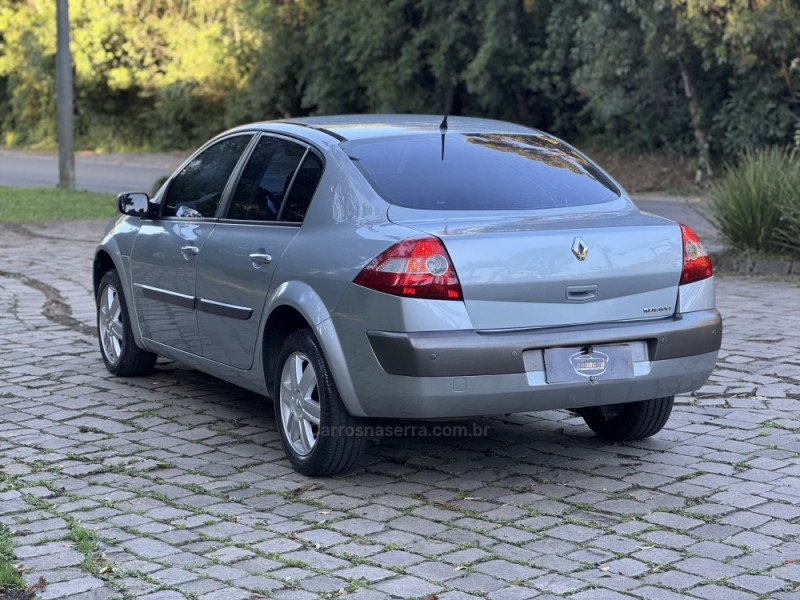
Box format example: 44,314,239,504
353,237,462,300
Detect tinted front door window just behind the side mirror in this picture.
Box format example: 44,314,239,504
161,135,252,217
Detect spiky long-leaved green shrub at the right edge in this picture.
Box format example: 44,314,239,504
708,147,800,253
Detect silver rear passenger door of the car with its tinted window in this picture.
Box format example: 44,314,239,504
197,135,322,369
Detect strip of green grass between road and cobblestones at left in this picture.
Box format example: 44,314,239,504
0,187,117,223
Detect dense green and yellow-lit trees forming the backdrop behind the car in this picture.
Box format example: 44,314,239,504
0,0,800,173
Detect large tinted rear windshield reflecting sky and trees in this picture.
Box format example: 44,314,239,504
342,132,619,210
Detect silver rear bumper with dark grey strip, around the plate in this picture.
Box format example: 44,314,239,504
346,309,722,418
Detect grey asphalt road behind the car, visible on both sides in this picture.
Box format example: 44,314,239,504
0,149,721,250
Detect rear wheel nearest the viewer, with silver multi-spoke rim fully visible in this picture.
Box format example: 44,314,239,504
273,329,366,477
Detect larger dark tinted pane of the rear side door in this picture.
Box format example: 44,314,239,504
227,137,306,221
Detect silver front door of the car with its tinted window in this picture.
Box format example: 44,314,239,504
131,134,253,355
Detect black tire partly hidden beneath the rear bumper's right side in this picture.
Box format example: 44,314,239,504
579,396,675,442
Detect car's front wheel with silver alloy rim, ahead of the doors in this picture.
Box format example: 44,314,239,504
96,269,158,377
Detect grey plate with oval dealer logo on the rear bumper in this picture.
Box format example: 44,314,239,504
544,344,633,383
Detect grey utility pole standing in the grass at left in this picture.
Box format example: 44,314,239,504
56,0,75,190
